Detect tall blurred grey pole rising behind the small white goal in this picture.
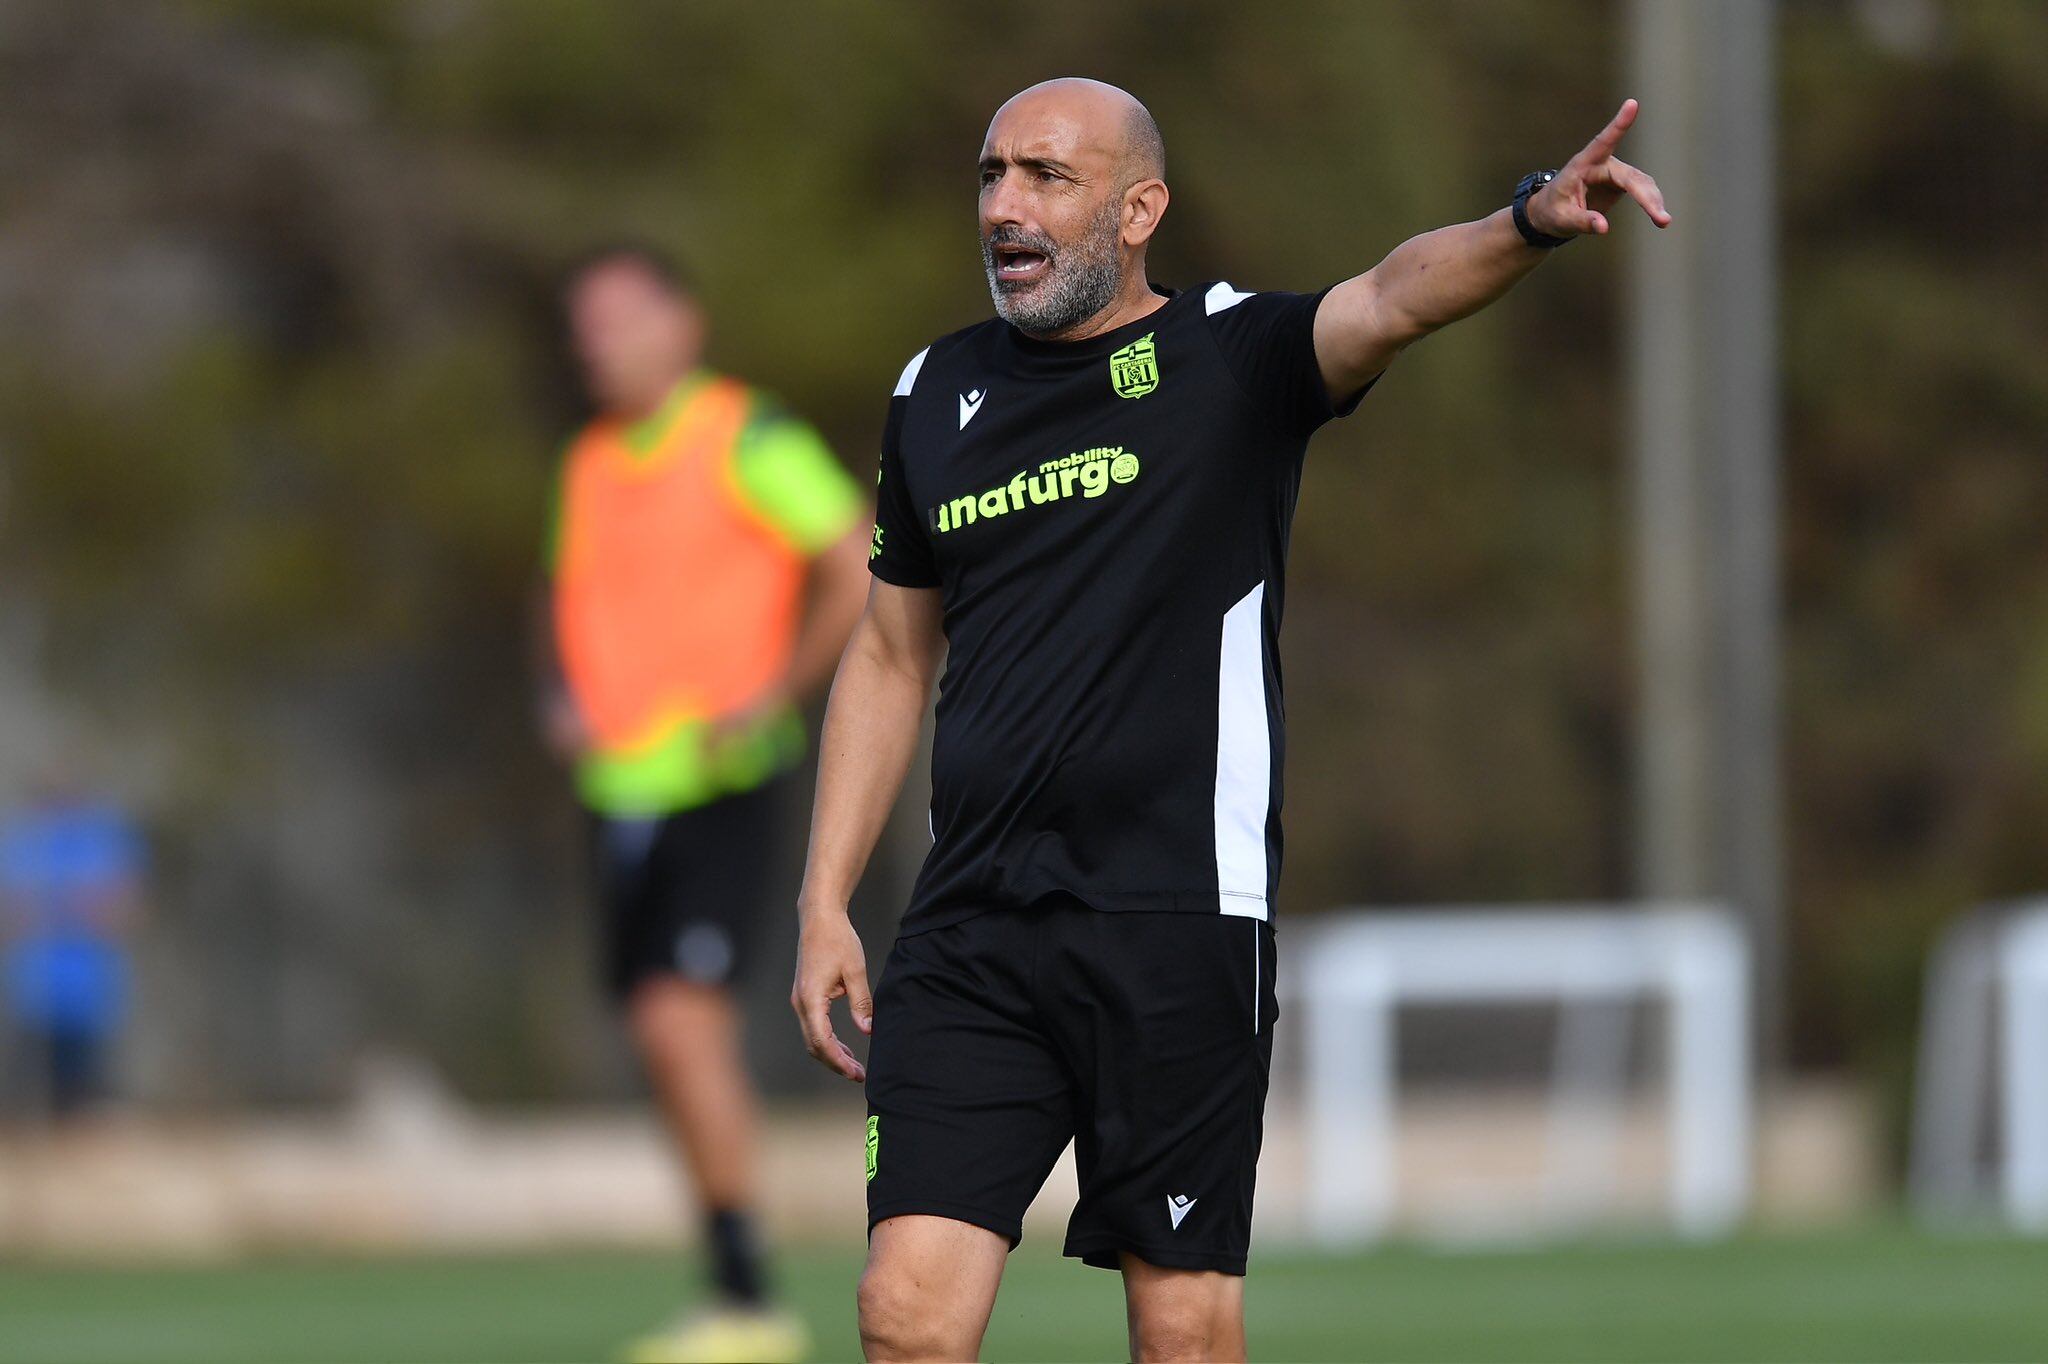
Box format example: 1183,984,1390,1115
1628,0,1784,1061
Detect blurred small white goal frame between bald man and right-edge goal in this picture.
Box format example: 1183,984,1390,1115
1282,905,1751,1247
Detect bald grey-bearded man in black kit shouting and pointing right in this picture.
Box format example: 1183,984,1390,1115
791,80,1671,1360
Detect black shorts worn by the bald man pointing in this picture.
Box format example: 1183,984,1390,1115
868,901,1280,1274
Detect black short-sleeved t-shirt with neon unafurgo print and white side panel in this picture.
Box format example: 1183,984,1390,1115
868,283,1370,932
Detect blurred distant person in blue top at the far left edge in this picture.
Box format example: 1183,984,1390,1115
0,768,145,1124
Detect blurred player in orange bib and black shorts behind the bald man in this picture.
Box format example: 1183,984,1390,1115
545,246,868,1360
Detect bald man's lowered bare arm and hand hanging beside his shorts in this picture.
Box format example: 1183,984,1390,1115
788,580,946,1081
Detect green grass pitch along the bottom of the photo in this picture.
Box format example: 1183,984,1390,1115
0,1229,2048,1364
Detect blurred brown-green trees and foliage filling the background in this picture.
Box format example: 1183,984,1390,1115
0,0,2048,1146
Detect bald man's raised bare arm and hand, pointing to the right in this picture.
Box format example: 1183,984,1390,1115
1315,100,1671,403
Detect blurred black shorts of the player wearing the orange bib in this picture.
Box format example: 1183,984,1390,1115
590,778,788,999
